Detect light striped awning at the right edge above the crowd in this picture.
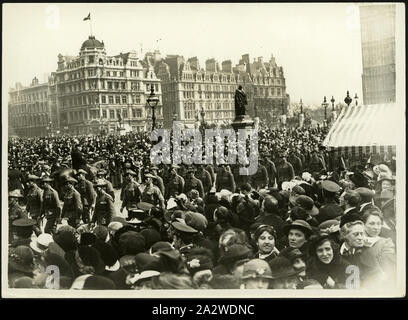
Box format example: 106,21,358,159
323,103,401,154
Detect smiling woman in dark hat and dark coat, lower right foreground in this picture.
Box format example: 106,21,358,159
306,235,350,289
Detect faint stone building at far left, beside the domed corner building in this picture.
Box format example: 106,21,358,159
8,78,52,136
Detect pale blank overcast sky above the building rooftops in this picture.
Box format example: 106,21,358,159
3,3,362,104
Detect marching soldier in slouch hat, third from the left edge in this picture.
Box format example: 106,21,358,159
41,176,62,234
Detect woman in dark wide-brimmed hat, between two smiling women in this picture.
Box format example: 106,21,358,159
283,220,313,260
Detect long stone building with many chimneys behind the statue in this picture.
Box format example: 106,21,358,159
154,55,289,128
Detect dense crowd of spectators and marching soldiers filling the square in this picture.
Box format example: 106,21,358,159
8,128,396,290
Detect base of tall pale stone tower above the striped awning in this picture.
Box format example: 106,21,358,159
360,4,396,104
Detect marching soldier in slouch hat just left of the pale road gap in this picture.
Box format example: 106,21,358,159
92,179,115,226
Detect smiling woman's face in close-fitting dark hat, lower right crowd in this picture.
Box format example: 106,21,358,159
254,225,279,263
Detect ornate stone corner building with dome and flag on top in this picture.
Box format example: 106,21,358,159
55,36,163,134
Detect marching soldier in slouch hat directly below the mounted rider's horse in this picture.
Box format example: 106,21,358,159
61,177,83,228
